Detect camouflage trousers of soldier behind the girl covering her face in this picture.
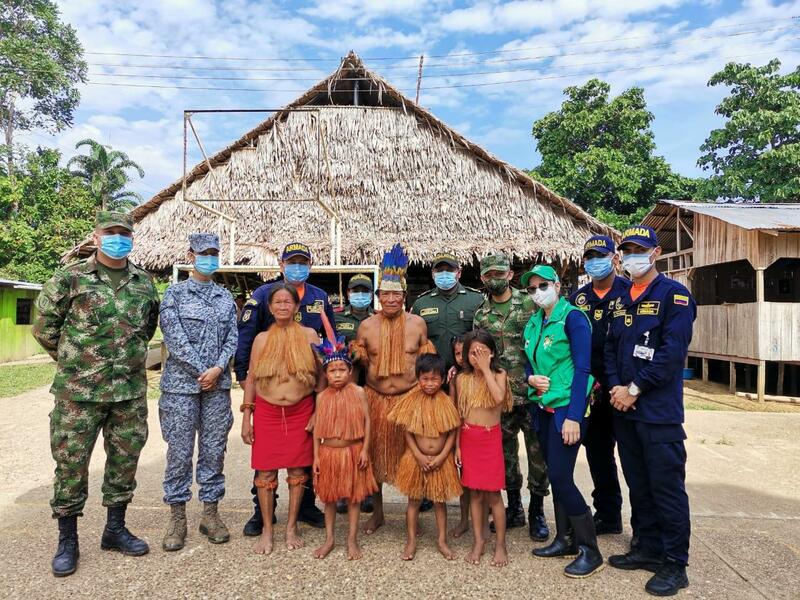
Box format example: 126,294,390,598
500,404,550,496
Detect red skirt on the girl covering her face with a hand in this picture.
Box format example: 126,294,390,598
461,422,506,492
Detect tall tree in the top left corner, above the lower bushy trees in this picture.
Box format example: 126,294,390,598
0,0,86,178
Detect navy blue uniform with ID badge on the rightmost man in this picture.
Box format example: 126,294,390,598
605,274,697,565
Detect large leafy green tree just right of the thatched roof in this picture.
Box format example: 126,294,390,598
531,79,698,228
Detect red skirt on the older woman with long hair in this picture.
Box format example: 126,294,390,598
250,395,314,471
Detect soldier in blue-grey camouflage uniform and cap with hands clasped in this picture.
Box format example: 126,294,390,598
158,233,238,551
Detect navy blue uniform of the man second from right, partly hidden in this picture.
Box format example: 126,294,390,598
569,276,631,526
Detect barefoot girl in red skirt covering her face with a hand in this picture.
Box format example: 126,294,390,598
451,329,512,567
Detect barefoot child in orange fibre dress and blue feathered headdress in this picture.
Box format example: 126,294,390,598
313,338,378,560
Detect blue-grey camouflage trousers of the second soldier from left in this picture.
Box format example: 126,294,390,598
158,390,233,504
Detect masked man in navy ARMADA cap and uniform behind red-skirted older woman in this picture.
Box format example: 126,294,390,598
233,242,334,536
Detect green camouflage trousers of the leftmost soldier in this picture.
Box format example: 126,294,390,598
50,397,147,518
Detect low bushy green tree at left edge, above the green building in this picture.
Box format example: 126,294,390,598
0,149,94,282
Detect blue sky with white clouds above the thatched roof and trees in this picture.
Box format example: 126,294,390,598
21,0,800,198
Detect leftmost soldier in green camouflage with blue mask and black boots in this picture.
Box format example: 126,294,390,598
33,211,158,576
